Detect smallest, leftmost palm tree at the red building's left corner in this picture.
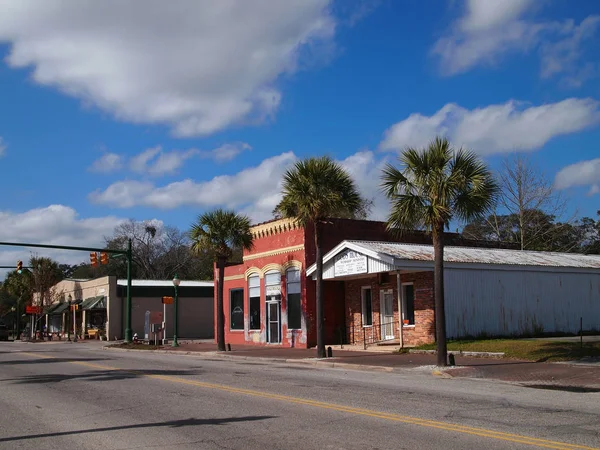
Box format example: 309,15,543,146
190,209,253,351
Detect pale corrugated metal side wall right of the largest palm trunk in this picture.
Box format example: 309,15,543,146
444,268,600,338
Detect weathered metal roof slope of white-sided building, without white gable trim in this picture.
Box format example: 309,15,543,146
346,241,600,269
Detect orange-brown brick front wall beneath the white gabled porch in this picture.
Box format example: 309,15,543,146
345,272,435,346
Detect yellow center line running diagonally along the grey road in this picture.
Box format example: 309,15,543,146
16,353,600,450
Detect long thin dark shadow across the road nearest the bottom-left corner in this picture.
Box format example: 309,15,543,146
0,416,276,442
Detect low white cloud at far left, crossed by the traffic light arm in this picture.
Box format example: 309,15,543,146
0,205,123,273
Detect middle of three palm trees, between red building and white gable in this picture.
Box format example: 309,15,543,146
275,156,365,358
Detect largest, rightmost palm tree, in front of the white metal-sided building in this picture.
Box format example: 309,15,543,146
382,137,498,366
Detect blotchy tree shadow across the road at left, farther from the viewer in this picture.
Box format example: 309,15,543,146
1,369,203,384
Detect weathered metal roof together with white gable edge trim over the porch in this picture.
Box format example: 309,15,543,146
306,240,600,275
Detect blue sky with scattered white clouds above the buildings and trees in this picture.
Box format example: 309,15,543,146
0,0,600,264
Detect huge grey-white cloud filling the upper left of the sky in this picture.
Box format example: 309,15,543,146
0,0,336,136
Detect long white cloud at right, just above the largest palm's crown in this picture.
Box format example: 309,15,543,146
379,98,600,155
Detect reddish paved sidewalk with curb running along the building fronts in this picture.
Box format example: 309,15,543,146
105,342,600,392
